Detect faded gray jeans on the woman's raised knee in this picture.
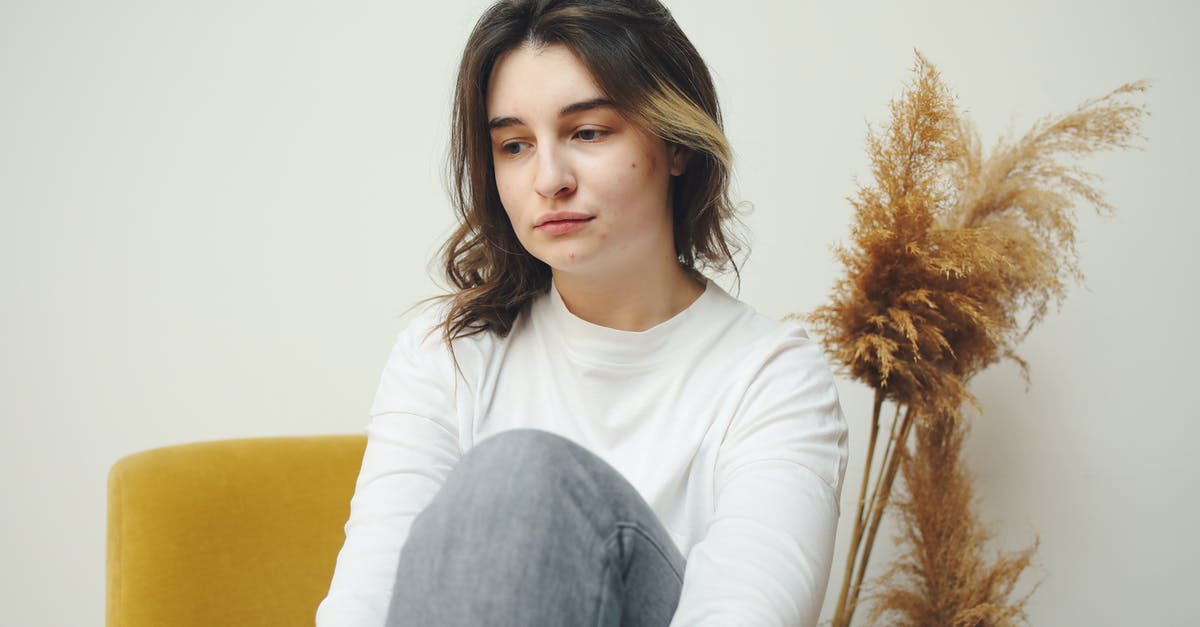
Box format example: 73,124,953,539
388,429,684,627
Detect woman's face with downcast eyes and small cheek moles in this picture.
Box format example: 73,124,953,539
487,46,684,277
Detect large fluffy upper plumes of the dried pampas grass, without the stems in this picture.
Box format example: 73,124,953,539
809,53,1147,416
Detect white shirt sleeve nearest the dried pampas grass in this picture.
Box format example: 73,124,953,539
671,329,847,627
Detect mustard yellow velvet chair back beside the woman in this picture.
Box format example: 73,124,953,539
107,436,366,627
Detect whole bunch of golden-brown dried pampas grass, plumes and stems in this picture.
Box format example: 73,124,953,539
808,53,1148,627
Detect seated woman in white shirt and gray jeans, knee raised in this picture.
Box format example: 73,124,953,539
317,0,846,627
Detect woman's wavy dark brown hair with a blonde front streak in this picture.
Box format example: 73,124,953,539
442,0,738,342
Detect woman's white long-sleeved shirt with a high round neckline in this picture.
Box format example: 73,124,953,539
317,281,846,627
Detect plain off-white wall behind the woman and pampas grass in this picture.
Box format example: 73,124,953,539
0,0,1200,626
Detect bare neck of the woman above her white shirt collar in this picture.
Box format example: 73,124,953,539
553,263,704,332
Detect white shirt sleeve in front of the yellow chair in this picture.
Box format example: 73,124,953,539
317,316,462,627
